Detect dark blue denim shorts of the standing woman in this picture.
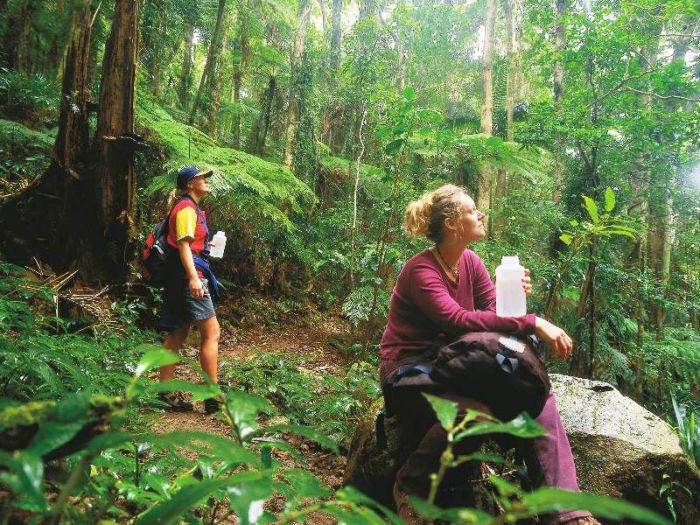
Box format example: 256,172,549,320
159,277,216,331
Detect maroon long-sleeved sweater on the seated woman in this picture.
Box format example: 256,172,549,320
380,250,535,384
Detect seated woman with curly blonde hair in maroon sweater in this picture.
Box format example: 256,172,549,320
380,184,599,525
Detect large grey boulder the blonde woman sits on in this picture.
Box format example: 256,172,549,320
344,374,700,525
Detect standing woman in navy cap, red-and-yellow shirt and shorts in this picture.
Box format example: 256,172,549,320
160,166,221,414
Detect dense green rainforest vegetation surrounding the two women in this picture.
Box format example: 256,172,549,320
0,0,700,525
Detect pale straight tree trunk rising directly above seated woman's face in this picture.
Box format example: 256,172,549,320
476,0,496,226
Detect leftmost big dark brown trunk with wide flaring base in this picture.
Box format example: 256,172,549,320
0,0,102,275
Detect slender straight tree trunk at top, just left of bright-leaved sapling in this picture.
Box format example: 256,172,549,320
552,0,567,202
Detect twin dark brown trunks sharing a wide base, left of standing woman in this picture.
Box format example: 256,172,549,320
0,0,139,279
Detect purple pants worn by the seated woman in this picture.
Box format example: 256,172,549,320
391,387,590,523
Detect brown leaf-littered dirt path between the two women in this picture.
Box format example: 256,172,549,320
144,304,358,525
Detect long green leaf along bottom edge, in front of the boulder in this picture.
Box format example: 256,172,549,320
522,488,672,525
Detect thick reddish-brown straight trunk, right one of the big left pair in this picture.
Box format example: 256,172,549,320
93,0,139,280
